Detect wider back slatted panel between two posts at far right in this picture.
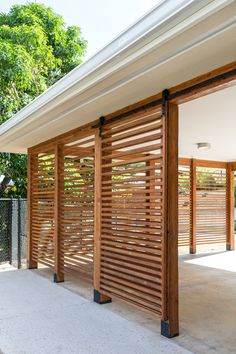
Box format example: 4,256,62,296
196,167,226,245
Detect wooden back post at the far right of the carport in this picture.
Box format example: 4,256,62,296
226,163,235,251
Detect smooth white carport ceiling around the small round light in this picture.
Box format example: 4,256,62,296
179,86,236,161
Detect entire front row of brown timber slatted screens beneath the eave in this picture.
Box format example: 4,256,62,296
29,106,166,318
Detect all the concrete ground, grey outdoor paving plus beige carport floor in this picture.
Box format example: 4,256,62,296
0,246,236,354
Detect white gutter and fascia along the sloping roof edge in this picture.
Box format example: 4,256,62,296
0,0,234,136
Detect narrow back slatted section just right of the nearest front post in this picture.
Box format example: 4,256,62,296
178,165,191,246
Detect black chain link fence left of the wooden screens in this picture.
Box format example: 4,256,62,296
0,198,27,268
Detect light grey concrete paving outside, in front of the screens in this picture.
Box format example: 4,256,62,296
0,270,190,354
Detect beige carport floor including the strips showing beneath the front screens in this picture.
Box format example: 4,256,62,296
37,248,236,354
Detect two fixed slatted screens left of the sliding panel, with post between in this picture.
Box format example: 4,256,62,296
28,129,94,281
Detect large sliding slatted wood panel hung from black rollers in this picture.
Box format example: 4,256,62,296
100,108,164,316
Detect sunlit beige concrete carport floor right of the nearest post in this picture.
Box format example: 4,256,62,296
173,247,236,354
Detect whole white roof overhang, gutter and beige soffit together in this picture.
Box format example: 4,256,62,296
0,0,236,152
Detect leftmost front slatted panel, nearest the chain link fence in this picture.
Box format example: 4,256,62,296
31,151,55,268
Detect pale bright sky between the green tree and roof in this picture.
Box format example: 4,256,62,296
0,0,160,58
